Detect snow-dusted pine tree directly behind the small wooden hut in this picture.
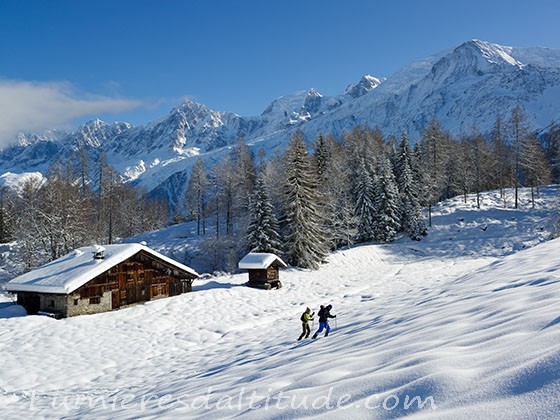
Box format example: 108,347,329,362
247,174,281,255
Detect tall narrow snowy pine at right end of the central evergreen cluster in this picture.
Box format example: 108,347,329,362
395,132,427,241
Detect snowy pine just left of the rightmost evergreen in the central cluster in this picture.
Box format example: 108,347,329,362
374,158,402,242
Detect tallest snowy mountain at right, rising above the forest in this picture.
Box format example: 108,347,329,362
305,40,560,141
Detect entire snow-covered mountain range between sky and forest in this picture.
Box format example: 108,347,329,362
0,40,560,210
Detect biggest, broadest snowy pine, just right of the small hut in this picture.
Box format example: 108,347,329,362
282,132,329,269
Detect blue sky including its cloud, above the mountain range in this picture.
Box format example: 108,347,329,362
0,0,560,141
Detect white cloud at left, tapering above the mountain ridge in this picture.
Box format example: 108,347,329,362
0,79,142,147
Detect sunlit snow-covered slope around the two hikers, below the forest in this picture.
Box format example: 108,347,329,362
0,187,560,419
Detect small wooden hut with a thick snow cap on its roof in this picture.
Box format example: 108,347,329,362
239,252,287,289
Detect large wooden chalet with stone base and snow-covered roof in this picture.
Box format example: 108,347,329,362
6,244,199,318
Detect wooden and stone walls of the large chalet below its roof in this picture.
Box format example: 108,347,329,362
17,251,196,318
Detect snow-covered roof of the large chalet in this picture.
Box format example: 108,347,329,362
6,243,199,294
